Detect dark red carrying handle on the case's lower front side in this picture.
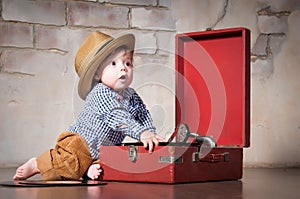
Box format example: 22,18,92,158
193,152,230,163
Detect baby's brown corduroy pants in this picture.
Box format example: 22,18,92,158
37,132,93,180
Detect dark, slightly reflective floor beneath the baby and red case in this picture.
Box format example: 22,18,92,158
0,168,300,199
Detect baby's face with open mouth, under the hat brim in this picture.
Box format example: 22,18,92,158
96,49,133,92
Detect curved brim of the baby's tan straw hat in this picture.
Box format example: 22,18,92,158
78,34,135,100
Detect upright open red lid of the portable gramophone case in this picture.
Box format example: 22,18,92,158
176,28,250,147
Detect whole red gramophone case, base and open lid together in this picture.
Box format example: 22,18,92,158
100,28,250,183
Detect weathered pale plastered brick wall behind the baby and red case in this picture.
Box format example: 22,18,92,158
0,0,300,167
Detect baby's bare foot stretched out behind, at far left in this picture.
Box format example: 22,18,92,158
13,158,40,180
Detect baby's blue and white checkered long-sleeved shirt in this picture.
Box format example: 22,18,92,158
69,83,155,160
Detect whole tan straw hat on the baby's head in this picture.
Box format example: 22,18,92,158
75,32,135,100
